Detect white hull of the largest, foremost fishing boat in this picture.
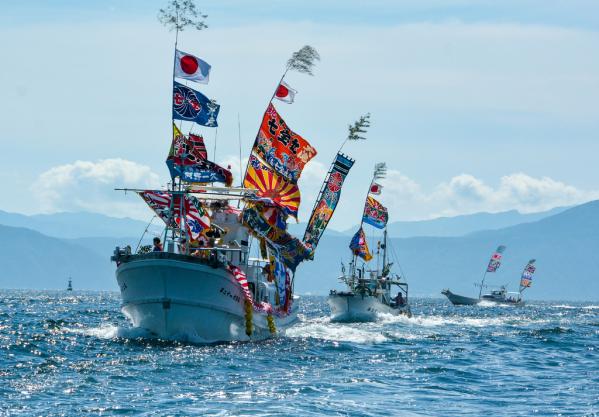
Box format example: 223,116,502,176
116,259,297,343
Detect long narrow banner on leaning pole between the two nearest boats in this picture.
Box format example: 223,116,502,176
303,153,355,250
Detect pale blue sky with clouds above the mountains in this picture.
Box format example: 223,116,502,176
0,0,599,230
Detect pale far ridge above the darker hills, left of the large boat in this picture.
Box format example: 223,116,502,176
0,210,160,238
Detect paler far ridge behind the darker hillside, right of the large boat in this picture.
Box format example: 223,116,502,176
344,207,567,237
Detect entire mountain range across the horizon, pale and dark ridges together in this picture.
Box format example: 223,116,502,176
0,201,599,300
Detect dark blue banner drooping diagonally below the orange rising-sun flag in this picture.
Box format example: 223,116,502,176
241,206,312,271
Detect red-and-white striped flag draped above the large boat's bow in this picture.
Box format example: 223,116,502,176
138,191,210,240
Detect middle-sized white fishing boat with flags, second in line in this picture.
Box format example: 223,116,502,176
327,163,412,322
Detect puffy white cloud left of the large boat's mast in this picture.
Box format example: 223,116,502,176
31,159,166,219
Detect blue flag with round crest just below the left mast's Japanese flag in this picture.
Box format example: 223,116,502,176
173,81,220,127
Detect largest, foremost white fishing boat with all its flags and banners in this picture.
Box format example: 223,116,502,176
112,1,354,343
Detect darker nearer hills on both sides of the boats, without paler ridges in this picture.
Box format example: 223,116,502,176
0,201,599,300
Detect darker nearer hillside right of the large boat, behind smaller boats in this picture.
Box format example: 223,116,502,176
295,201,599,300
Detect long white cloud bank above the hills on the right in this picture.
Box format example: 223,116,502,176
382,170,599,220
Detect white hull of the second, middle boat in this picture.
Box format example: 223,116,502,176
327,293,411,322
